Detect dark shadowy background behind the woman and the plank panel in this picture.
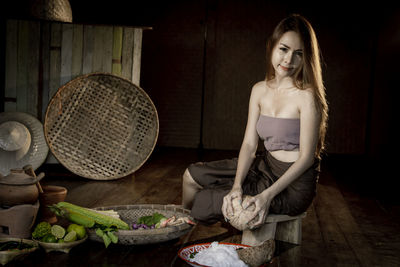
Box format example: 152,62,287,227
0,0,400,201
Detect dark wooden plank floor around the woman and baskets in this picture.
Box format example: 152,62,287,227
17,148,400,266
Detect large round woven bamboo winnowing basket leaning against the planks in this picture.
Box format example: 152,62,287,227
43,73,159,180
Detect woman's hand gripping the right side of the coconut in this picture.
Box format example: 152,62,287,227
243,191,272,229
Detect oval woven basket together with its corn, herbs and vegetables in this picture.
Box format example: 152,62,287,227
50,202,195,247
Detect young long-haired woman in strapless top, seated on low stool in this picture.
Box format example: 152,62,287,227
182,15,328,228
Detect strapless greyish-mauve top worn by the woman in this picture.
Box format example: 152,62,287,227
257,114,300,151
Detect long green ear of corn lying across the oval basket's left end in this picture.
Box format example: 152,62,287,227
55,202,129,230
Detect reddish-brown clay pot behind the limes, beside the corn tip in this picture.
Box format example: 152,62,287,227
39,185,68,224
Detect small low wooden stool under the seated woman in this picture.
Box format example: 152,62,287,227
242,212,306,246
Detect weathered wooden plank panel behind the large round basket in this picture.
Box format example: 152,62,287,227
4,20,143,121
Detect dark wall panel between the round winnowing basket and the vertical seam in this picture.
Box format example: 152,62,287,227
141,0,205,150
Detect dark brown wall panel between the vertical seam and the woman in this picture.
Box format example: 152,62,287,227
203,0,284,150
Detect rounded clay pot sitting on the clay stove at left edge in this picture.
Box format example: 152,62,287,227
0,169,44,207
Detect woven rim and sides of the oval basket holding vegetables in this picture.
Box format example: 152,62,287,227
89,204,193,245
